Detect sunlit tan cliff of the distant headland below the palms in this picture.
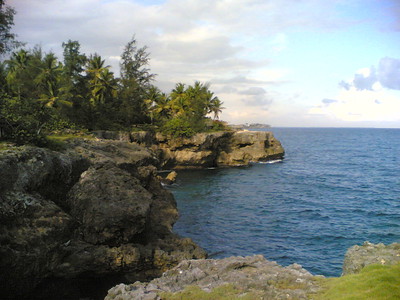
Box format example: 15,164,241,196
97,131,284,168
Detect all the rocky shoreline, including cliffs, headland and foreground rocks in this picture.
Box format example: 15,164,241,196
0,131,400,300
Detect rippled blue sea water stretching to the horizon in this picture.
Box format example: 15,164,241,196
171,128,400,276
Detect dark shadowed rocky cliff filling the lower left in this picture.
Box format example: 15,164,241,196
0,140,206,299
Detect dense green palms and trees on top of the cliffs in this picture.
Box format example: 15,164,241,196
0,0,224,145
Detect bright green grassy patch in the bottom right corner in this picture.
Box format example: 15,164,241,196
313,264,400,300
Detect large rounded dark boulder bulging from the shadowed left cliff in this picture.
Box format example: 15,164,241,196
68,164,152,246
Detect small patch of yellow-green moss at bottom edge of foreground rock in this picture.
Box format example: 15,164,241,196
160,284,260,300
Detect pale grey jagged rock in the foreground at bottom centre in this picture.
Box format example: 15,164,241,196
105,255,320,300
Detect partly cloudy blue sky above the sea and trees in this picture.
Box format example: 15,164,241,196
6,0,400,128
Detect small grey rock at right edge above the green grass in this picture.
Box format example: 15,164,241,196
343,242,400,275
